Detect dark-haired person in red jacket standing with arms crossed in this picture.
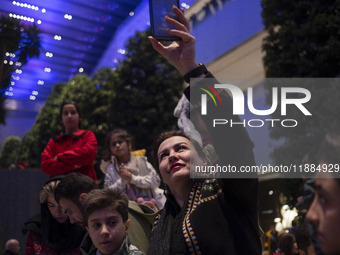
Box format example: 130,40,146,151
41,101,97,180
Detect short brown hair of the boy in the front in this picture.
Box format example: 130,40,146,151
84,189,129,225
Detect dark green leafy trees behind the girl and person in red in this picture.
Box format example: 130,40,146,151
19,32,183,175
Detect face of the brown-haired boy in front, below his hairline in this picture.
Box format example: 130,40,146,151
86,207,130,255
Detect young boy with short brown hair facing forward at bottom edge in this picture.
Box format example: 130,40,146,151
84,189,144,255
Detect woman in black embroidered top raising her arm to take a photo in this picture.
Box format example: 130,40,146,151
148,6,262,255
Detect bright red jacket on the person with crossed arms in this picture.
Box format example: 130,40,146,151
41,129,97,180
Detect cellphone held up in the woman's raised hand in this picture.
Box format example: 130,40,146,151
149,0,181,41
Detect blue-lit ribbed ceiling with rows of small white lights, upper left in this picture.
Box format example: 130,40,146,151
0,0,142,102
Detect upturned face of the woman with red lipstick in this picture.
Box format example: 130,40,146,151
157,136,199,190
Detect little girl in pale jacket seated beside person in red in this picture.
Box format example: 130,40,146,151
104,129,165,209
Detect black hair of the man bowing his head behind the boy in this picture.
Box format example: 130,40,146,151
54,172,98,208
